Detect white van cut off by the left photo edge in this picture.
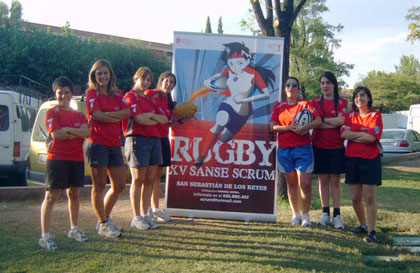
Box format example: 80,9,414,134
0,87,41,186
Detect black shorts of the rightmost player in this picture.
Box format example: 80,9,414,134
346,155,382,186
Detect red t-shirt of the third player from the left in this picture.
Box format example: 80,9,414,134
123,90,160,137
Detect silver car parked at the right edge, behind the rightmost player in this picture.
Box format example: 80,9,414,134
381,129,420,153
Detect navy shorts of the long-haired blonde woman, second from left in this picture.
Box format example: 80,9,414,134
85,141,124,167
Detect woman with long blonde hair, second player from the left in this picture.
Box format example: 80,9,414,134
86,60,130,238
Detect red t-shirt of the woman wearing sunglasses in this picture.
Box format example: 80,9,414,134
270,99,319,148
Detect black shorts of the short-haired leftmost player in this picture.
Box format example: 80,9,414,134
45,159,85,191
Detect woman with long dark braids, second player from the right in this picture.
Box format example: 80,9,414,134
312,71,347,229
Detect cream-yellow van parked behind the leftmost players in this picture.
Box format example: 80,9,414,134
29,96,131,184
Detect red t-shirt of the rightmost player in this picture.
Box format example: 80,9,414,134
341,111,383,159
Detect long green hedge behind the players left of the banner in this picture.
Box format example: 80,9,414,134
0,20,170,94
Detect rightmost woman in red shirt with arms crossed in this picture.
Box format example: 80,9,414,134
341,86,383,243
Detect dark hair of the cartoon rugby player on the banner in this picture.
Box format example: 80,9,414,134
220,42,276,87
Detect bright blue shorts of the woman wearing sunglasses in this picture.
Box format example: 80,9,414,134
277,145,314,173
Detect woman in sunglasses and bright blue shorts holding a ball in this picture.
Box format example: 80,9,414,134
270,77,322,226
